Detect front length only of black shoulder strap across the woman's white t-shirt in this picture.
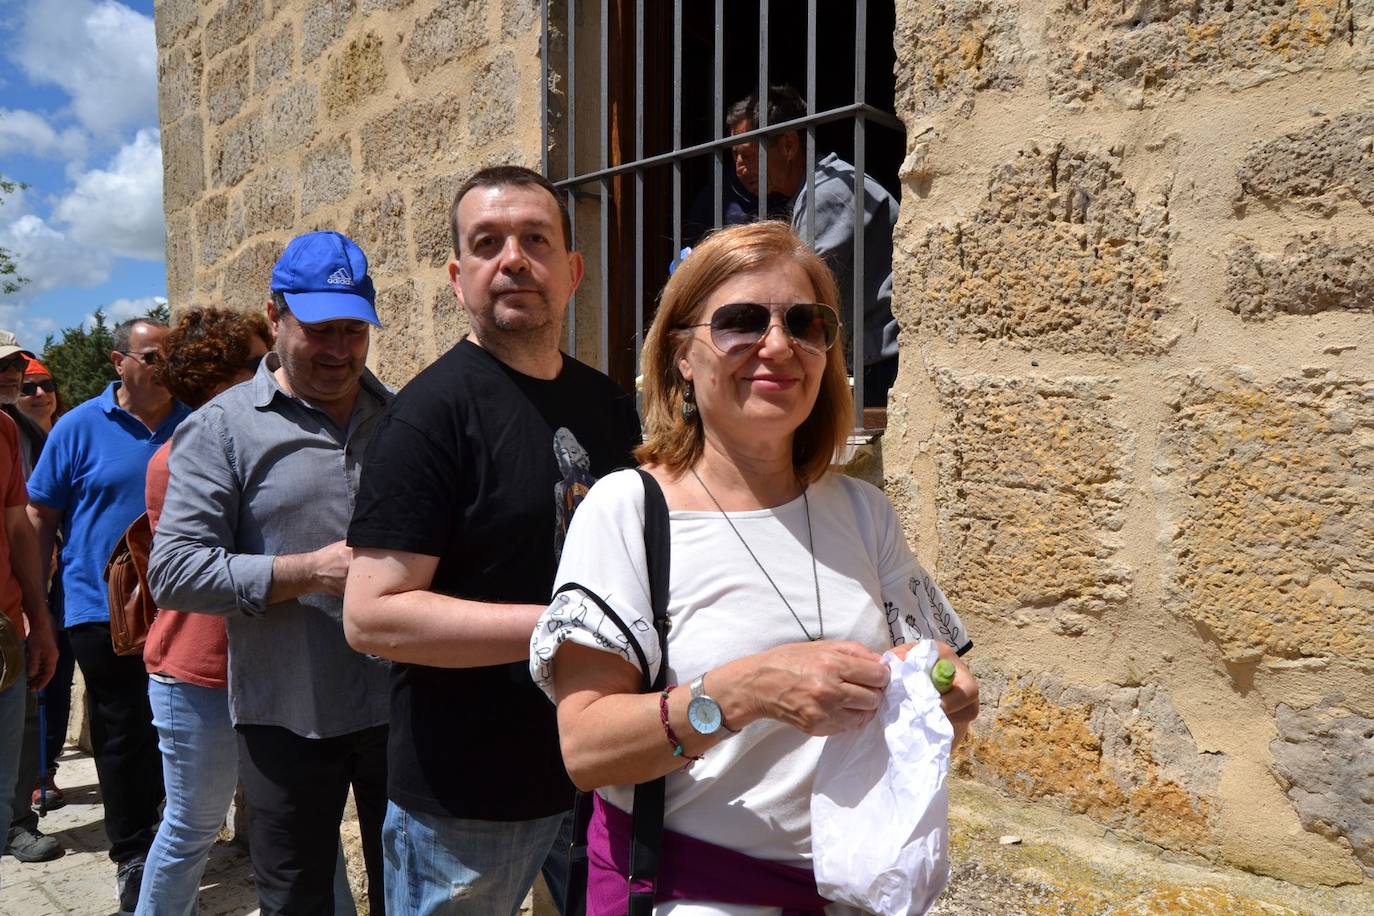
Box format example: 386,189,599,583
629,468,672,916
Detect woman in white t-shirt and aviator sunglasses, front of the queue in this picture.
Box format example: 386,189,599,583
530,222,978,916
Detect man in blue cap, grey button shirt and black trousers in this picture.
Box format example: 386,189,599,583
148,232,390,916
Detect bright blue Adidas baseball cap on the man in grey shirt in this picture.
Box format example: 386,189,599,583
272,232,382,327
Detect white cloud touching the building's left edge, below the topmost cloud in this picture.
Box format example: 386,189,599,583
52,130,165,261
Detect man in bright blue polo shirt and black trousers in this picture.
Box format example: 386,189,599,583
29,319,190,911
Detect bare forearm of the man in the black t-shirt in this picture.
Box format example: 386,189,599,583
344,590,544,667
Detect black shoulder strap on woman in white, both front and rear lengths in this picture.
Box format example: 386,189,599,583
563,468,672,916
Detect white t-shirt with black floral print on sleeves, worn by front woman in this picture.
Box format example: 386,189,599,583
530,471,971,916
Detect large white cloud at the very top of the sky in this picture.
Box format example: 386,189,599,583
10,0,158,137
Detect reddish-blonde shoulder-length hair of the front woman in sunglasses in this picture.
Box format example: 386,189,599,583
635,221,853,483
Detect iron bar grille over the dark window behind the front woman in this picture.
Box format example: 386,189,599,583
540,0,905,426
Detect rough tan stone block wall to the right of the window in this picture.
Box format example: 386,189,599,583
883,0,1374,884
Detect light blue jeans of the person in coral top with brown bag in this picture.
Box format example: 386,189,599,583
137,678,239,916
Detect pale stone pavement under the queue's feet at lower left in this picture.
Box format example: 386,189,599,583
0,748,258,916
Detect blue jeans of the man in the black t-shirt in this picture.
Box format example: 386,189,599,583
382,802,572,916
